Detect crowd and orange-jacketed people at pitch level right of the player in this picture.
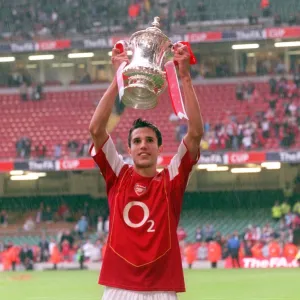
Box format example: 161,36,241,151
177,200,300,268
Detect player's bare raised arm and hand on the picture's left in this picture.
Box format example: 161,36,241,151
89,48,128,152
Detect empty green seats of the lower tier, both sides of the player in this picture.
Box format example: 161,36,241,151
0,190,283,245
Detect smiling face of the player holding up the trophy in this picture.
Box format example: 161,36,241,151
128,127,161,168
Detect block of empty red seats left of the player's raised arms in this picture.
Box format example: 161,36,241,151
0,91,102,158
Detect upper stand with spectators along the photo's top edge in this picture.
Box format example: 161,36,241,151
0,0,300,40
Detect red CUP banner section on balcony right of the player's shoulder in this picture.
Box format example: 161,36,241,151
224,152,266,164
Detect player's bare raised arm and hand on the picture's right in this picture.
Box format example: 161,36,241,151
174,44,204,159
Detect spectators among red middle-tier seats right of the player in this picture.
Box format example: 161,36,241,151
191,77,300,151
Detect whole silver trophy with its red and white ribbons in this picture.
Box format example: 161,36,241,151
115,17,195,118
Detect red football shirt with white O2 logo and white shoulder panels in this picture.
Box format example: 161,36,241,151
90,137,197,292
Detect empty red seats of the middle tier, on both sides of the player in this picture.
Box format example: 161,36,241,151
0,83,300,159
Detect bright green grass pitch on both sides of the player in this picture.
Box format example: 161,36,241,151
0,269,300,300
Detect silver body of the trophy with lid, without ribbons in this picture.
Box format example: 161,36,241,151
121,17,173,109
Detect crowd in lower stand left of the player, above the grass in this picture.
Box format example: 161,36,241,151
0,202,109,270
